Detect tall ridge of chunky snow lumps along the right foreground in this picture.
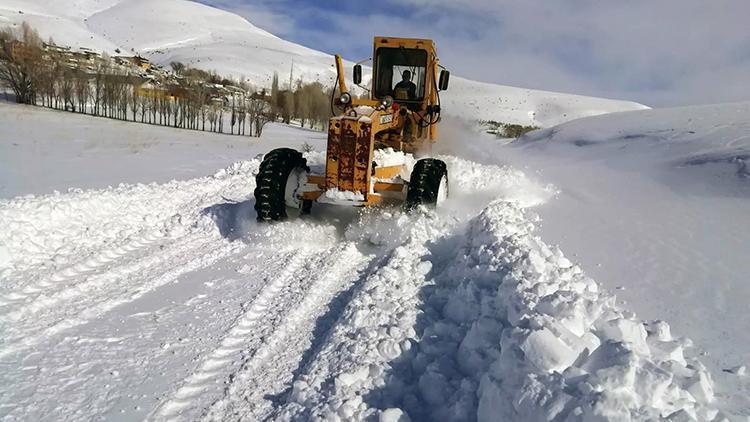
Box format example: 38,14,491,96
468,202,717,421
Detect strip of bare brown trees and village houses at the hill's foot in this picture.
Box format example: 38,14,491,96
0,23,330,136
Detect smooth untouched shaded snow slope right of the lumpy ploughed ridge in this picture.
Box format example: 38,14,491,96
506,102,750,415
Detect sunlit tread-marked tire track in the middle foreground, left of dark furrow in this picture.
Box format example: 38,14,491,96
150,243,369,421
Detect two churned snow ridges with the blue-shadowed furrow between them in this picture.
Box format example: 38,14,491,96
276,200,718,421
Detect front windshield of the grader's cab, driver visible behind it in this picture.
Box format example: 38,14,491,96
375,47,427,101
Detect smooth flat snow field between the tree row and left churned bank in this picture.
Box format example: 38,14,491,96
0,101,325,198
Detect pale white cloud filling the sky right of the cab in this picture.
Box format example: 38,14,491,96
384,0,750,104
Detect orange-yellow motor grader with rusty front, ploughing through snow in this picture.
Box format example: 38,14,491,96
255,37,450,221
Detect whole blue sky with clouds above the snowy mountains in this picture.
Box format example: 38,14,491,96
201,0,750,106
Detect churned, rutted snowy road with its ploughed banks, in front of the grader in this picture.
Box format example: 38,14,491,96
0,146,732,420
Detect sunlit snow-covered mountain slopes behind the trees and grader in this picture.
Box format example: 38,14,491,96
0,0,645,127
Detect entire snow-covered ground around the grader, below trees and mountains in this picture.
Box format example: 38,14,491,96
0,100,750,421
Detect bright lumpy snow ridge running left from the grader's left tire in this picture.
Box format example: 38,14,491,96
0,160,260,281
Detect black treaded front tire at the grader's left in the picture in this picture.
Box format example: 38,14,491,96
255,148,310,221
